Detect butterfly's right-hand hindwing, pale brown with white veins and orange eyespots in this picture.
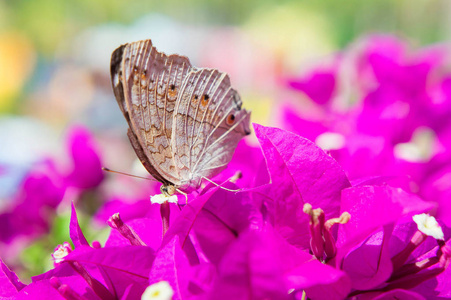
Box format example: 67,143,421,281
172,69,250,191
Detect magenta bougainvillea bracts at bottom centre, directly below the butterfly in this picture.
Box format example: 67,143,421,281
154,171,350,299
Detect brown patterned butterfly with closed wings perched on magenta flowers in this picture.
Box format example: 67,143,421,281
111,40,250,196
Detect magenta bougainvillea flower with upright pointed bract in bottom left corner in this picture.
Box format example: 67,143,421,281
0,202,155,299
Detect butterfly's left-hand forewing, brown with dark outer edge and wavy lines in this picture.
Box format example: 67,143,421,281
111,40,193,185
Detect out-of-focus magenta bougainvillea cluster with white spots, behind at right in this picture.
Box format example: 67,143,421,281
281,35,451,225
